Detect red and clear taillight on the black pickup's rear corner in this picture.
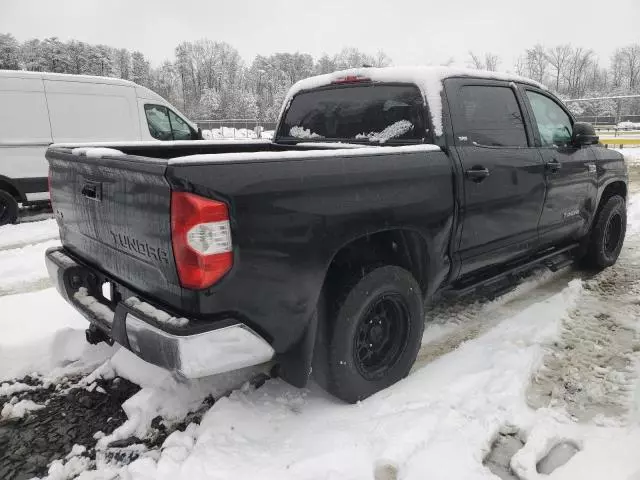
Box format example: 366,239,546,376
171,192,233,290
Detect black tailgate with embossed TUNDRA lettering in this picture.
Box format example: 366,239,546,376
47,148,182,305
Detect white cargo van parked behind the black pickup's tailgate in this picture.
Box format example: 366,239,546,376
0,70,202,225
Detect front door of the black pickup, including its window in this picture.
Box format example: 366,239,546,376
525,87,598,244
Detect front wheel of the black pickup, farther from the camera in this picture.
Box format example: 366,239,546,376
583,195,627,270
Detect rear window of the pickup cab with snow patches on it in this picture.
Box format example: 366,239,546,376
278,84,425,144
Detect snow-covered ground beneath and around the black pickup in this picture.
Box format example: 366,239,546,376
0,149,640,480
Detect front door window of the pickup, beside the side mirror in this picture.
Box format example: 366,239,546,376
527,90,573,146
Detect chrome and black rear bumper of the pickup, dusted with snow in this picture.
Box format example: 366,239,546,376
45,248,274,378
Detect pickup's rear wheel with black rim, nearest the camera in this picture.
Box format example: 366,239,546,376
322,266,424,403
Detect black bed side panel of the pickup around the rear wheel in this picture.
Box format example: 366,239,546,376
167,151,454,352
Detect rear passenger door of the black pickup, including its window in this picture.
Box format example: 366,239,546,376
445,79,545,275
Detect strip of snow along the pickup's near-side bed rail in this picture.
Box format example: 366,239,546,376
169,144,441,165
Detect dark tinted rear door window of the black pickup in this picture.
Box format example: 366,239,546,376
453,85,528,147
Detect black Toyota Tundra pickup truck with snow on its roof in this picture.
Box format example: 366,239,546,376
46,67,627,402
